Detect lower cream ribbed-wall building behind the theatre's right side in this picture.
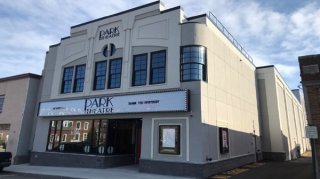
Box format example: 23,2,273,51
256,65,310,160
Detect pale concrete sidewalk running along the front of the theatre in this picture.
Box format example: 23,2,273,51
3,164,195,179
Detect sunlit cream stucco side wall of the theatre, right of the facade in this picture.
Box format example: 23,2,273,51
182,18,260,162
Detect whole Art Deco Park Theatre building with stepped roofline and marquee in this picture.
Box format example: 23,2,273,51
31,1,261,177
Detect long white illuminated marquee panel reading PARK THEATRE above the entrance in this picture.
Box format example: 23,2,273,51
39,90,188,116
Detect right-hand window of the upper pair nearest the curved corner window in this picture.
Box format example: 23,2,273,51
150,51,166,84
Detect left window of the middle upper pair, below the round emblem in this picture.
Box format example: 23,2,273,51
93,61,107,90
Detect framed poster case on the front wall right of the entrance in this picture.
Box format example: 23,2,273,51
159,125,180,155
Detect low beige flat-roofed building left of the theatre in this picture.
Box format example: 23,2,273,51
0,73,41,164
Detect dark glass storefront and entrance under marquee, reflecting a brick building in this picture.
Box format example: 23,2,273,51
47,120,137,155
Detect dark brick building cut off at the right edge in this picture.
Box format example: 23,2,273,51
299,54,320,170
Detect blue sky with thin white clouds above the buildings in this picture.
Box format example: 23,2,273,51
0,0,320,88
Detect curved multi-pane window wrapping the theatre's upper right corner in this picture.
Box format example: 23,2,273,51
180,46,207,81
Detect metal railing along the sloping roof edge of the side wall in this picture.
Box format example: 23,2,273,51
208,12,253,63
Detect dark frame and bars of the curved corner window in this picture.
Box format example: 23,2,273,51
180,45,208,82
